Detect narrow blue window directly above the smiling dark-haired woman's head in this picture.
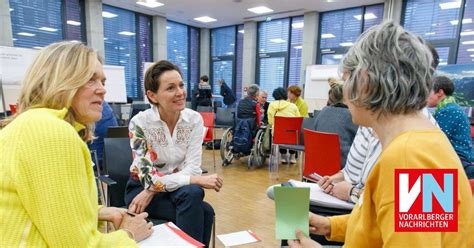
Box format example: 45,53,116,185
166,21,199,100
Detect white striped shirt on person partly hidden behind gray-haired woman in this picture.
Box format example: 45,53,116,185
342,108,438,188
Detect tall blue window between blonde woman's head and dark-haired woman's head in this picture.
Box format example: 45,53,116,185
102,5,152,100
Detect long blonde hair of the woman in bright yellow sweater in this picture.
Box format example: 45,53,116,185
1,42,102,141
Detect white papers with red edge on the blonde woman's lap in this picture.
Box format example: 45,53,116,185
138,222,204,247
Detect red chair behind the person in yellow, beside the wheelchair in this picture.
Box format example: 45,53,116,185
269,116,304,177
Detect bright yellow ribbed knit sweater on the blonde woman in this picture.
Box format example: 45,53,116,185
0,109,136,247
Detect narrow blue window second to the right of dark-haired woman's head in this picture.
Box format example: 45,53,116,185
210,26,236,95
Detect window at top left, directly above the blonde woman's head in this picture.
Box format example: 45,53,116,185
10,0,86,48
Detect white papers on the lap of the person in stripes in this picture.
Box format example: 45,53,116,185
288,179,354,209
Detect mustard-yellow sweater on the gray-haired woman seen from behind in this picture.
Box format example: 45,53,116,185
328,130,474,247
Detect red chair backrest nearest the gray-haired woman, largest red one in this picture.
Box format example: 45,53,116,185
303,129,341,179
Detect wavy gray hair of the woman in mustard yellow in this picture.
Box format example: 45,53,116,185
340,21,433,115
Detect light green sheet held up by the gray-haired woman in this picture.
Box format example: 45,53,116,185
274,186,309,239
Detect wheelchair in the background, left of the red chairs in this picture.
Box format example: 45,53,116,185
220,126,269,169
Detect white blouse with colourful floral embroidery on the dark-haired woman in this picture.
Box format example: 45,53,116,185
129,106,204,192
